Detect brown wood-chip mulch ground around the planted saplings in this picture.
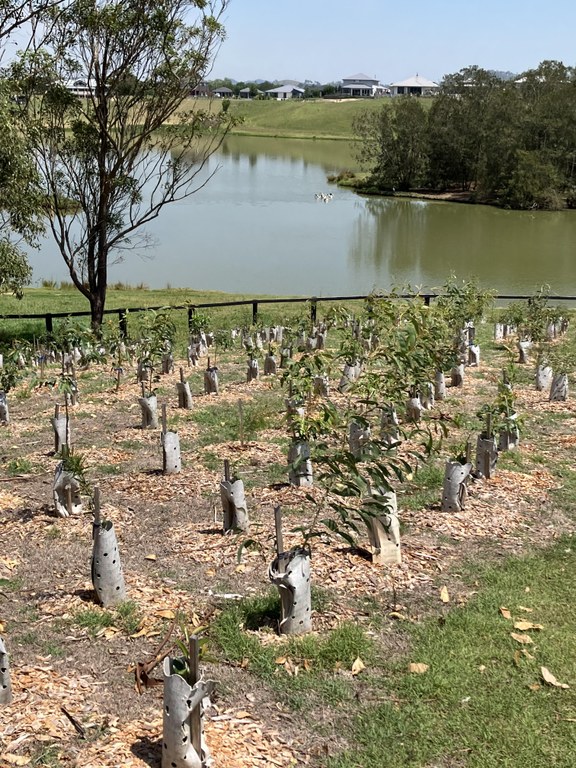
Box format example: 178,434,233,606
0,344,576,768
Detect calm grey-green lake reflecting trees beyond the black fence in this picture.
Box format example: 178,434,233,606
30,136,576,296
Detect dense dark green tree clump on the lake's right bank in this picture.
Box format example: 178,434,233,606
354,61,576,210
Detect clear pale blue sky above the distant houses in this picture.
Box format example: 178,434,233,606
209,0,576,83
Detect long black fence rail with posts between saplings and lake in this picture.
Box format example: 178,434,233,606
1,293,576,338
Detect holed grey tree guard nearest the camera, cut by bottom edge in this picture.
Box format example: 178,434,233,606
162,656,215,768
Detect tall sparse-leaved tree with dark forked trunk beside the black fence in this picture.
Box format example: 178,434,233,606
12,0,228,330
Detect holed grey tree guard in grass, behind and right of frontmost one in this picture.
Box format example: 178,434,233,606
268,547,312,635
